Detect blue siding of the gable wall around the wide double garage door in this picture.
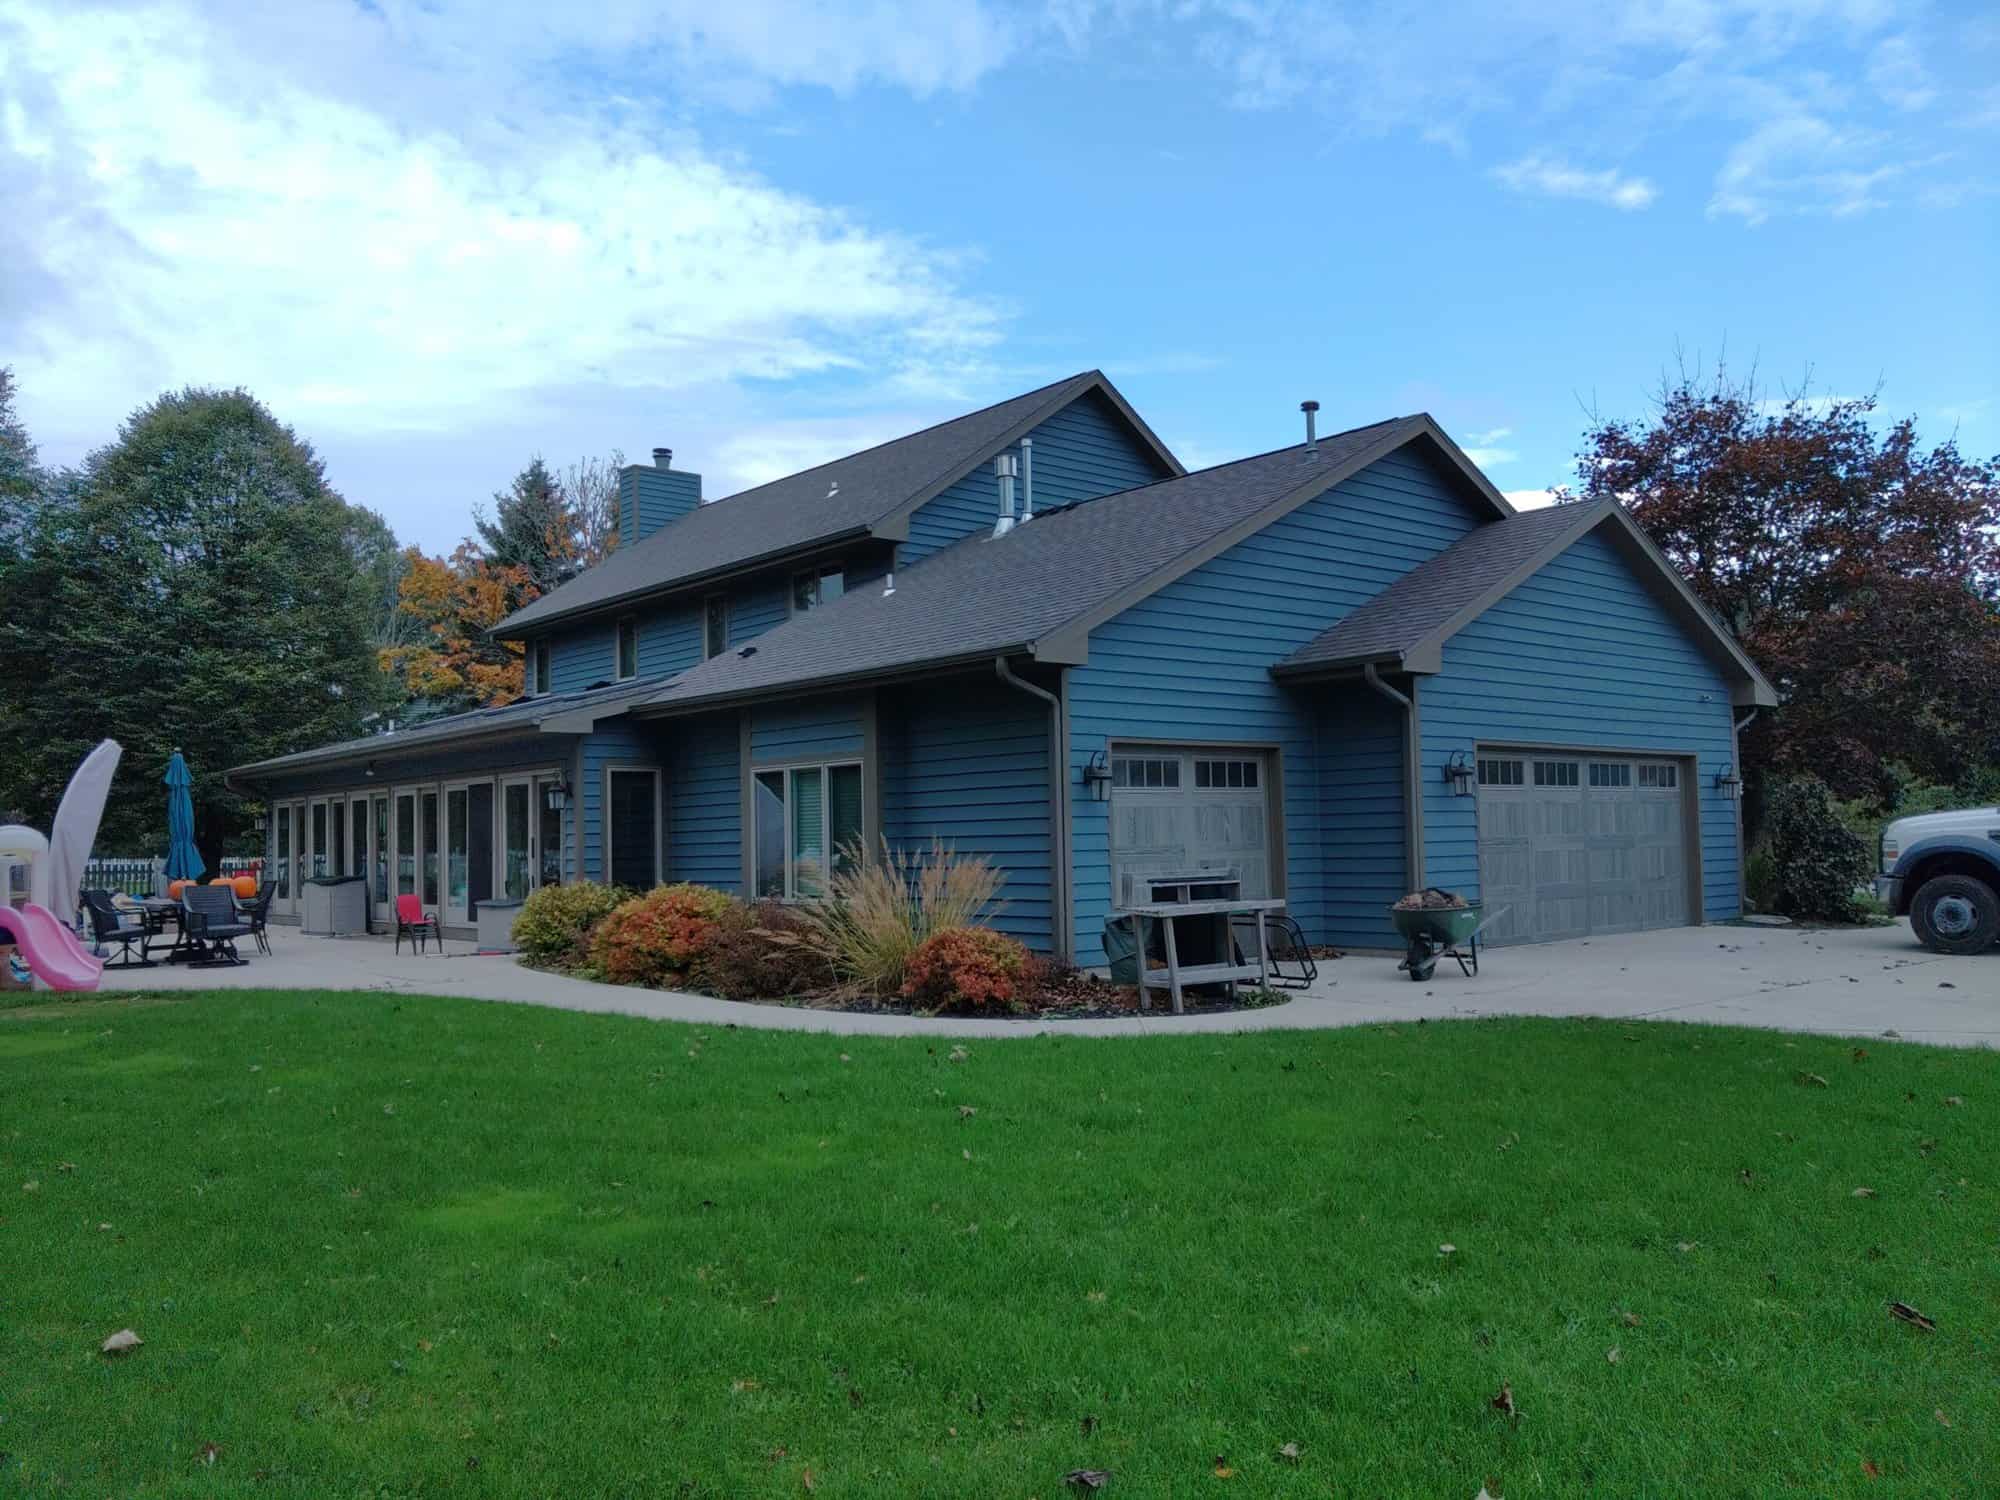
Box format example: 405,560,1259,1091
1420,532,1742,922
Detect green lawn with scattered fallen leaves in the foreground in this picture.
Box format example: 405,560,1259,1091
0,992,2000,1500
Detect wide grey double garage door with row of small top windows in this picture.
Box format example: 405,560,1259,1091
1478,748,1692,942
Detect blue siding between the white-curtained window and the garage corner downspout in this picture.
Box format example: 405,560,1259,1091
878,680,1054,954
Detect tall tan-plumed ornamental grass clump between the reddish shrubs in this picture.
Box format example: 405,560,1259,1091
800,838,1004,996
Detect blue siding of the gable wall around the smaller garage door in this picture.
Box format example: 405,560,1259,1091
1080,444,1484,964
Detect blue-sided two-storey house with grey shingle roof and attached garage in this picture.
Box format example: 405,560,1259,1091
232,372,1776,966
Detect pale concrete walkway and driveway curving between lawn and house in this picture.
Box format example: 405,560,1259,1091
82,922,2000,1046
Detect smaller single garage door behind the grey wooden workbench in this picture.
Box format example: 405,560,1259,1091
1112,746,1272,906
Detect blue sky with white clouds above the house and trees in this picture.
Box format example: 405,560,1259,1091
0,0,2000,550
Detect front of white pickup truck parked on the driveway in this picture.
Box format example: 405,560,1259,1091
1876,808,2000,954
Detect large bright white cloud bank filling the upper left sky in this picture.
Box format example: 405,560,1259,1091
0,0,998,478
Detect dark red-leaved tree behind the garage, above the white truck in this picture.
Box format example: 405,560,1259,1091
1568,370,2000,798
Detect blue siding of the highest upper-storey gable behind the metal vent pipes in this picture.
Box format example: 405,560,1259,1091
902,392,1168,566
